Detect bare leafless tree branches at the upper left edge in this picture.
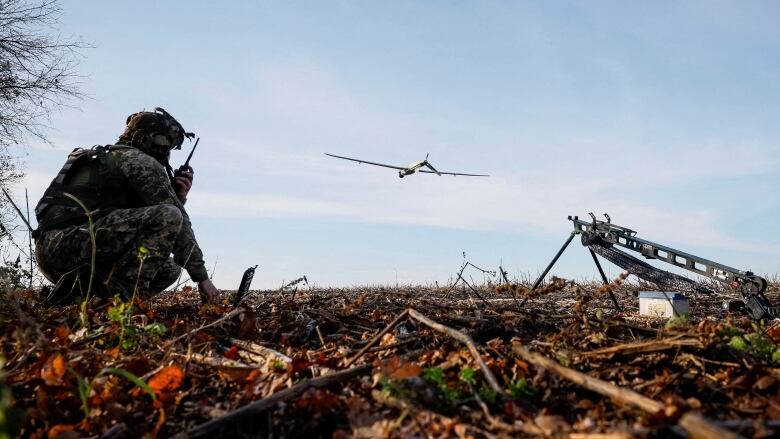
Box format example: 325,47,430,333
0,0,89,288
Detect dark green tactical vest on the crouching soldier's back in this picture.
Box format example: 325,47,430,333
33,145,134,237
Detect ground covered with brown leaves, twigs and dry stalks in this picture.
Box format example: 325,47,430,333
0,276,780,438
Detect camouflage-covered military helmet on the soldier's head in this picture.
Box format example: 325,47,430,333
119,107,195,158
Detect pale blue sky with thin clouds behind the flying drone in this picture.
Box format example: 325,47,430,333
10,0,780,289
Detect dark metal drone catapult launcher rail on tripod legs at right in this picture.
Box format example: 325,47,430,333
532,213,780,320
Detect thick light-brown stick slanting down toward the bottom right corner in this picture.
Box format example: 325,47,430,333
512,341,741,439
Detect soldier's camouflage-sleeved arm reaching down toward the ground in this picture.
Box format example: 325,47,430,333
109,149,209,282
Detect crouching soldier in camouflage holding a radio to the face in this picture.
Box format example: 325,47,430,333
33,108,219,303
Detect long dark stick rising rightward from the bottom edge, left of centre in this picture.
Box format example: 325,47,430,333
174,364,373,439
